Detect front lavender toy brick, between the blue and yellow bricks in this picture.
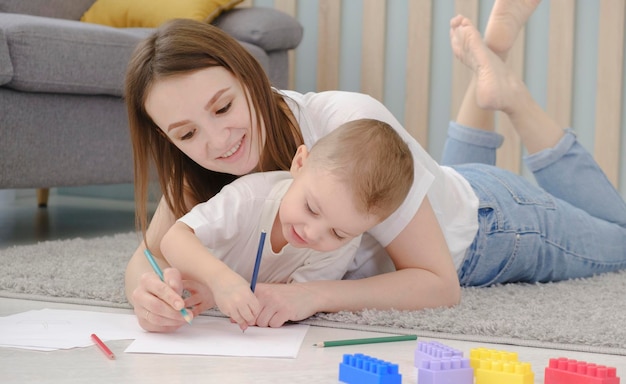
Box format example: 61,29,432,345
417,357,474,384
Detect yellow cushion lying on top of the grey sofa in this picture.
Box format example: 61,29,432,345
80,0,243,28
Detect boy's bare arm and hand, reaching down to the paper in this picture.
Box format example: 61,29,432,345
161,221,260,329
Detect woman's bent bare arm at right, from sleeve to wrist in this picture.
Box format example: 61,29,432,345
308,198,461,312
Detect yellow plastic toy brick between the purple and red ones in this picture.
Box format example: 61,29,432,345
470,348,535,384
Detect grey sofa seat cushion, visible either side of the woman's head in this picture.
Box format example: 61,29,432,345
0,13,269,96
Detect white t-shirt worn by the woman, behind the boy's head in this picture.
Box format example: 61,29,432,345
280,91,478,270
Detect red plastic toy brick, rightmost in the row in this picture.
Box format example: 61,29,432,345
544,357,619,384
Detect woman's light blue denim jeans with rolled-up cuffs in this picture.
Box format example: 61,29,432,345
441,123,626,286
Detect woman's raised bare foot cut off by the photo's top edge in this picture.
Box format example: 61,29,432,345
485,0,541,60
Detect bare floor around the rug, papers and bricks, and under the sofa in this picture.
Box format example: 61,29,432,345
0,190,626,384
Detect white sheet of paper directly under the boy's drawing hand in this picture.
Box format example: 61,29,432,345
124,316,309,358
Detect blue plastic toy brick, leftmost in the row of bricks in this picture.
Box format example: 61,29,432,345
339,353,402,384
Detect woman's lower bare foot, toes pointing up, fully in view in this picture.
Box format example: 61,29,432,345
450,15,523,113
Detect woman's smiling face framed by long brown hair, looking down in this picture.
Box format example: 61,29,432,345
145,67,263,176
